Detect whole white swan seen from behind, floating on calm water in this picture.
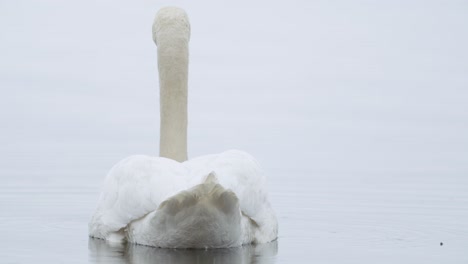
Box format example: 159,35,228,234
88,7,278,248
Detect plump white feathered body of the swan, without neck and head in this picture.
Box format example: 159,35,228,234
89,151,277,247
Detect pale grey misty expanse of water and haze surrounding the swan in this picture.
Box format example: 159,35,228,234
0,0,468,263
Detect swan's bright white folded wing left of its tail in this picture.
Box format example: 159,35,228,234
89,155,187,239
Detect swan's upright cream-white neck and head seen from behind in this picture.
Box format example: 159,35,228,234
153,7,190,162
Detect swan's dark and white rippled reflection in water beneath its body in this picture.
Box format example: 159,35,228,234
88,238,278,264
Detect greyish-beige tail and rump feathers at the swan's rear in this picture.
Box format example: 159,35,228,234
128,172,242,248
